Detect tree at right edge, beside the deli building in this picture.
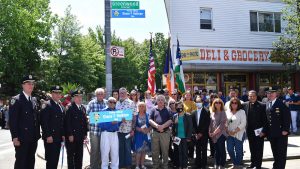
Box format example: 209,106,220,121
270,0,300,71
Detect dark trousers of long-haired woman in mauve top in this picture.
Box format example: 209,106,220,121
215,135,226,167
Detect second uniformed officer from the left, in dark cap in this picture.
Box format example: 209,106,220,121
41,86,65,169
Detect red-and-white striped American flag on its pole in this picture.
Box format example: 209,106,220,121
148,36,156,95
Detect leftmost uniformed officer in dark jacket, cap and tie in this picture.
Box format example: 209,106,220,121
9,75,41,169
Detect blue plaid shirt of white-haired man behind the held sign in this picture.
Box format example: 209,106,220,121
87,98,107,136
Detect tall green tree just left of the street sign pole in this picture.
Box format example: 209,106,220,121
42,6,104,92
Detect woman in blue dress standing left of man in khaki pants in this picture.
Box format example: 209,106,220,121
134,102,151,169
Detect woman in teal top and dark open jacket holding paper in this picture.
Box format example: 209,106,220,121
172,101,193,168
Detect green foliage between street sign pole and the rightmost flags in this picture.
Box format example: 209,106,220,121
112,33,167,91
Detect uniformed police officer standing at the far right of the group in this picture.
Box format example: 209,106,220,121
263,87,291,169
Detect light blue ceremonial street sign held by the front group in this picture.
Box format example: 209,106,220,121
89,109,133,124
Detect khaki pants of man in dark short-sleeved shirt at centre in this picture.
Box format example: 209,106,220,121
151,131,170,169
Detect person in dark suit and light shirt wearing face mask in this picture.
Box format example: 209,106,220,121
192,97,210,168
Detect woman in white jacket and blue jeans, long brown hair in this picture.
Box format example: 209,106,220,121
226,97,247,168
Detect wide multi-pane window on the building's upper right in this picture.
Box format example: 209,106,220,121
250,12,281,33
